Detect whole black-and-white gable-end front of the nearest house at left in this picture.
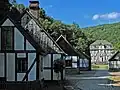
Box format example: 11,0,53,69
0,16,40,81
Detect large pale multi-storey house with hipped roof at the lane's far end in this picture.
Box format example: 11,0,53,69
90,40,113,64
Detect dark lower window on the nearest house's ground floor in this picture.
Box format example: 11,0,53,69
17,58,28,73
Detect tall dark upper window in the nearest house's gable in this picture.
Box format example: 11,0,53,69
1,27,14,50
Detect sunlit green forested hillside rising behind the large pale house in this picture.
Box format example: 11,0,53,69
82,23,120,49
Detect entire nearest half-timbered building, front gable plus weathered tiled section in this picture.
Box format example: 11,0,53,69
0,1,64,81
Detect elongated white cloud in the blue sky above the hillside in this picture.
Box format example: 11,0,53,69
92,12,120,20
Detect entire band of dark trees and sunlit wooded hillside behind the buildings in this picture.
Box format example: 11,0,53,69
13,2,120,54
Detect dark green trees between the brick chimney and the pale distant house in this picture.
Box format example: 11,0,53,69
40,9,94,53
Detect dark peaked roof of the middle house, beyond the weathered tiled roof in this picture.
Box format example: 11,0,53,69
56,35,90,59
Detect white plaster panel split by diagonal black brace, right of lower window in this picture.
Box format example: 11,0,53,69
28,53,36,81
